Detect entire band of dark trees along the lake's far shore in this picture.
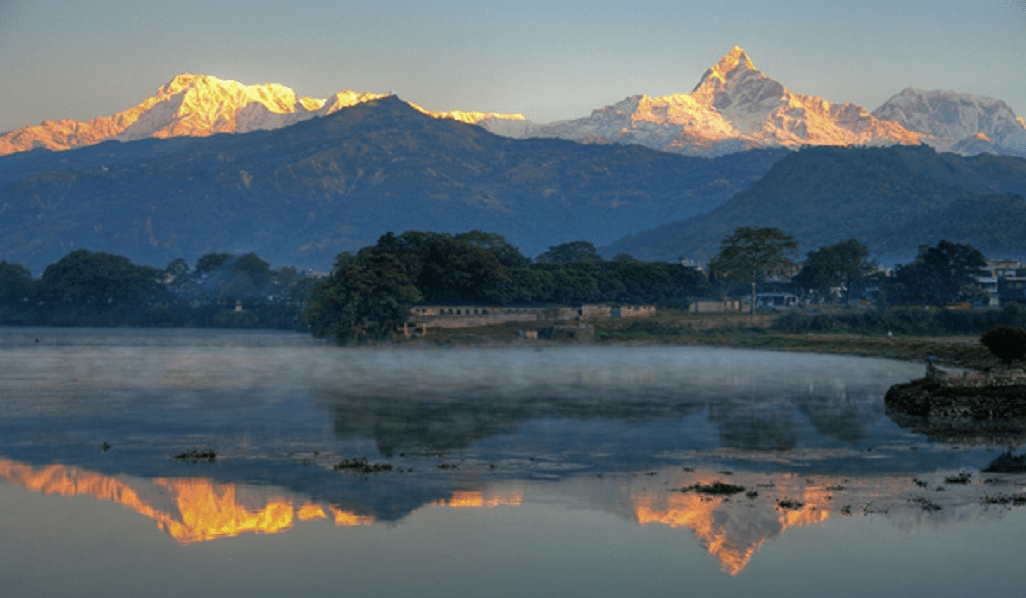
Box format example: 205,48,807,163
0,227,1011,343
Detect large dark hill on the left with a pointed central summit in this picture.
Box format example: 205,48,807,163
0,96,785,271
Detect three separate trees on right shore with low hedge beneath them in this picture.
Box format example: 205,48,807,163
710,227,1026,338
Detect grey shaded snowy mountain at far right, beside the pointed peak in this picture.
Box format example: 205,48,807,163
873,87,1026,156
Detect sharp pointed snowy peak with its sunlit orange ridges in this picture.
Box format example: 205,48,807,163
517,46,922,155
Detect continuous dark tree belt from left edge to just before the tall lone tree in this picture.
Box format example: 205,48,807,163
0,231,710,341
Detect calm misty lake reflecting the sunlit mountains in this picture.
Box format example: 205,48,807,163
0,328,1026,598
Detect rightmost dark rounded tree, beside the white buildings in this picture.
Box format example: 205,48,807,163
894,241,987,306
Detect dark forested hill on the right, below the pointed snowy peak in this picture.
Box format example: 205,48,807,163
602,146,1026,262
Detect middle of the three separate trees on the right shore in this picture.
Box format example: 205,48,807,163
794,239,876,301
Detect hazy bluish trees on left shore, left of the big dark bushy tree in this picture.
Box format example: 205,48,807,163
0,249,315,329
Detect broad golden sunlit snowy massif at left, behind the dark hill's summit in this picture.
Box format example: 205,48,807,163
0,74,523,155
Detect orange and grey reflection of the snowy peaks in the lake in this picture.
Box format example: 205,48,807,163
0,460,1026,575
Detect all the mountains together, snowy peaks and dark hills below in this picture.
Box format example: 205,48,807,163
0,47,1026,271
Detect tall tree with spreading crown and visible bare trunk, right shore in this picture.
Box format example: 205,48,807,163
710,227,798,314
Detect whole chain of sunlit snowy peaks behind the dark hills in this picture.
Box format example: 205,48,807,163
0,47,1026,156
